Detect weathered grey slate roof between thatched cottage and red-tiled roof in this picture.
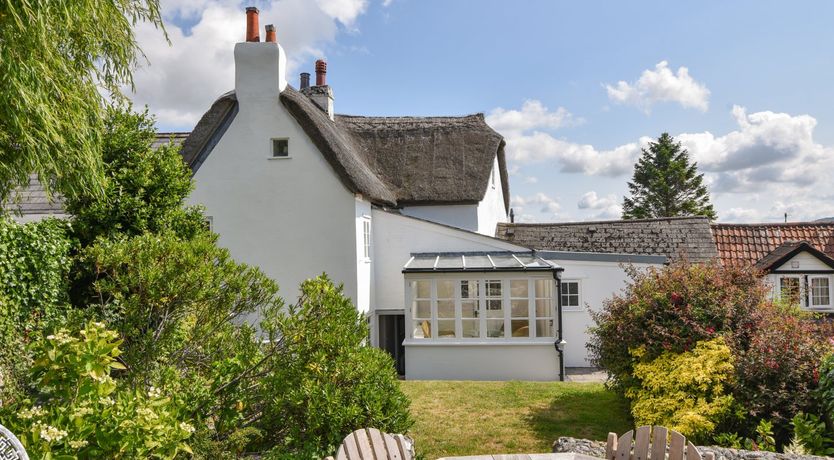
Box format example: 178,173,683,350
496,217,718,262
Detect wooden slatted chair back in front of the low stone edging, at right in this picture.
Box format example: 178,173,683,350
605,426,715,460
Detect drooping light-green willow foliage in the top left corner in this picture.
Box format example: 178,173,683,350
0,0,162,202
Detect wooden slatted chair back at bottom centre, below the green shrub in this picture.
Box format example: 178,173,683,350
326,428,414,460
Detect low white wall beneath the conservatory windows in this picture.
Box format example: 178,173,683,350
405,340,559,381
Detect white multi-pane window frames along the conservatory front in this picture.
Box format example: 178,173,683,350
405,272,559,345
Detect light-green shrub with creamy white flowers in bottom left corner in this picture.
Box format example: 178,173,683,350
3,323,194,459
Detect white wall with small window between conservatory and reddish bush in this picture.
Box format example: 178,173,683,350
548,259,664,367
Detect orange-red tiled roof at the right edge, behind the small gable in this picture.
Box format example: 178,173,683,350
712,222,834,266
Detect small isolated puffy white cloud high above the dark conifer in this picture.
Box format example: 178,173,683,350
605,61,710,113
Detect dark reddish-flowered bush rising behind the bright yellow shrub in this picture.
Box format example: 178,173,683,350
588,262,767,392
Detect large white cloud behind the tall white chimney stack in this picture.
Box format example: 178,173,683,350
133,0,367,130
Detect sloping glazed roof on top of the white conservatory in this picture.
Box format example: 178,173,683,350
403,251,562,273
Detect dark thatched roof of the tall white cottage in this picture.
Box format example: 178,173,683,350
182,86,510,209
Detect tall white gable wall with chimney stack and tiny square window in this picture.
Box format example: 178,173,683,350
189,43,358,310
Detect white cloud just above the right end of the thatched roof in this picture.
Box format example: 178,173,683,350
486,99,583,137
